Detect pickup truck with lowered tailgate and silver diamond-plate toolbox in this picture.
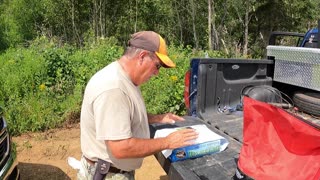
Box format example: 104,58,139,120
150,24,320,180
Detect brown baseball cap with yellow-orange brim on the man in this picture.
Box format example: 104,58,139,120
129,31,176,68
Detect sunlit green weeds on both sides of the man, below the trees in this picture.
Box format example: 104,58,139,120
0,38,226,135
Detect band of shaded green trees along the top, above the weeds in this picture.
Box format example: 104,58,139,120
0,0,320,57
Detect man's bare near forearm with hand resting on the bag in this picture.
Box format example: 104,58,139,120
105,129,198,159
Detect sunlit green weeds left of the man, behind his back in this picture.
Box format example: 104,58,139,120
0,37,123,135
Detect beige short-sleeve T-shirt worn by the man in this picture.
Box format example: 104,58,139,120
80,61,150,171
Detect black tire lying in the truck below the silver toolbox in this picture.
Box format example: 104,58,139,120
293,91,320,116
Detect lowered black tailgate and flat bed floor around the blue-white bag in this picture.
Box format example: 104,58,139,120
150,114,243,180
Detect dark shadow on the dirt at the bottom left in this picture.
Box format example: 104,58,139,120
18,162,71,180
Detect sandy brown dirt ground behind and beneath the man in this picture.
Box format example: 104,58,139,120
13,124,168,180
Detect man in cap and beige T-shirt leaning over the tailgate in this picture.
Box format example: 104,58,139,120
78,31,198,180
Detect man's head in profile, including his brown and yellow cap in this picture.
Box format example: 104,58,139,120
120,31,176,86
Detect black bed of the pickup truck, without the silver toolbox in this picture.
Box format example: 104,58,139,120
150,54,320,180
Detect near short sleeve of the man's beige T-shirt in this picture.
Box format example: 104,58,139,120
93,89,132,140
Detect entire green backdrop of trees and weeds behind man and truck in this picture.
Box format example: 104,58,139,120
0,0,320,134
